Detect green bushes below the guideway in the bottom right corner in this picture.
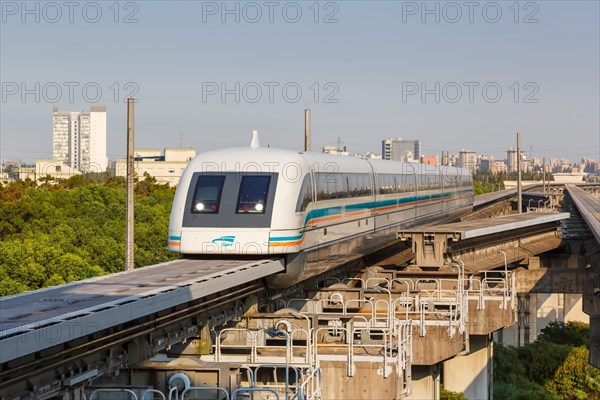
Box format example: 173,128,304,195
494,322,600,400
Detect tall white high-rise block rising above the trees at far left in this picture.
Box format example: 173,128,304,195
52,106,108,172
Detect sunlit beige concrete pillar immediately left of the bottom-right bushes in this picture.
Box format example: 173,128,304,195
444,335,492,400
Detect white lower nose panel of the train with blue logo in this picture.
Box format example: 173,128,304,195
180,228,269,254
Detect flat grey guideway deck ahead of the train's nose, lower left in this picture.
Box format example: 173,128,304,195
0,259,284,363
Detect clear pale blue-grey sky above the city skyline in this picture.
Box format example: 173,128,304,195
0,0,600,162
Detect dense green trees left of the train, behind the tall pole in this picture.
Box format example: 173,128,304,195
0,174,176,296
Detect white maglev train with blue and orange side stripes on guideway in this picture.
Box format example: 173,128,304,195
168,132,473,287
